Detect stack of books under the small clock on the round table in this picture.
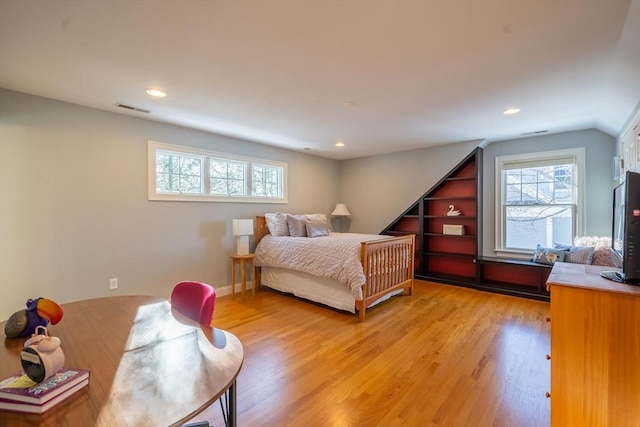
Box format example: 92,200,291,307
0,368,89,414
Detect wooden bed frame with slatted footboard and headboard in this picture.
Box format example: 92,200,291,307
256,216,415,321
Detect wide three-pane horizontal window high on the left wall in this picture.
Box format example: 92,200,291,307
148,141,287,203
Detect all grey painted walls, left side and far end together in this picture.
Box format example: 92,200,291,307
0,90,615,320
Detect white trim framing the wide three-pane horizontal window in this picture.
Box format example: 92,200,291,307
147,141,288,203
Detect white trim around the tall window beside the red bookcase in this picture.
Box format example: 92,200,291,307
494,147,586,259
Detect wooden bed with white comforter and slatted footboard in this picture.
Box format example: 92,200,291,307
255,214,415,321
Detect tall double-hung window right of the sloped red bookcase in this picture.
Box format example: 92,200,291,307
496,149,584,255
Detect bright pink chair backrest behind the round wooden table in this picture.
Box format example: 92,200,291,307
171,282,216,326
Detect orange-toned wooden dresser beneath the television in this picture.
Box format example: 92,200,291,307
547,263,640,427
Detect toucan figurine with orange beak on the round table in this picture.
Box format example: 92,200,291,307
4,298,63,338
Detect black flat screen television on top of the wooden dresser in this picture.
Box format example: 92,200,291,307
602,171,640,285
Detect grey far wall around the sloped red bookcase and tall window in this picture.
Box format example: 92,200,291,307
340,130,615,256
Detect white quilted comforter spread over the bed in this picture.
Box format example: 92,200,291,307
256,233,389,301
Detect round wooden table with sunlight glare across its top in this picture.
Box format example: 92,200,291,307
0,296,244,427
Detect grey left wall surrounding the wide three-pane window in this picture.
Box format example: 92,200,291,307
0,90,339,320
